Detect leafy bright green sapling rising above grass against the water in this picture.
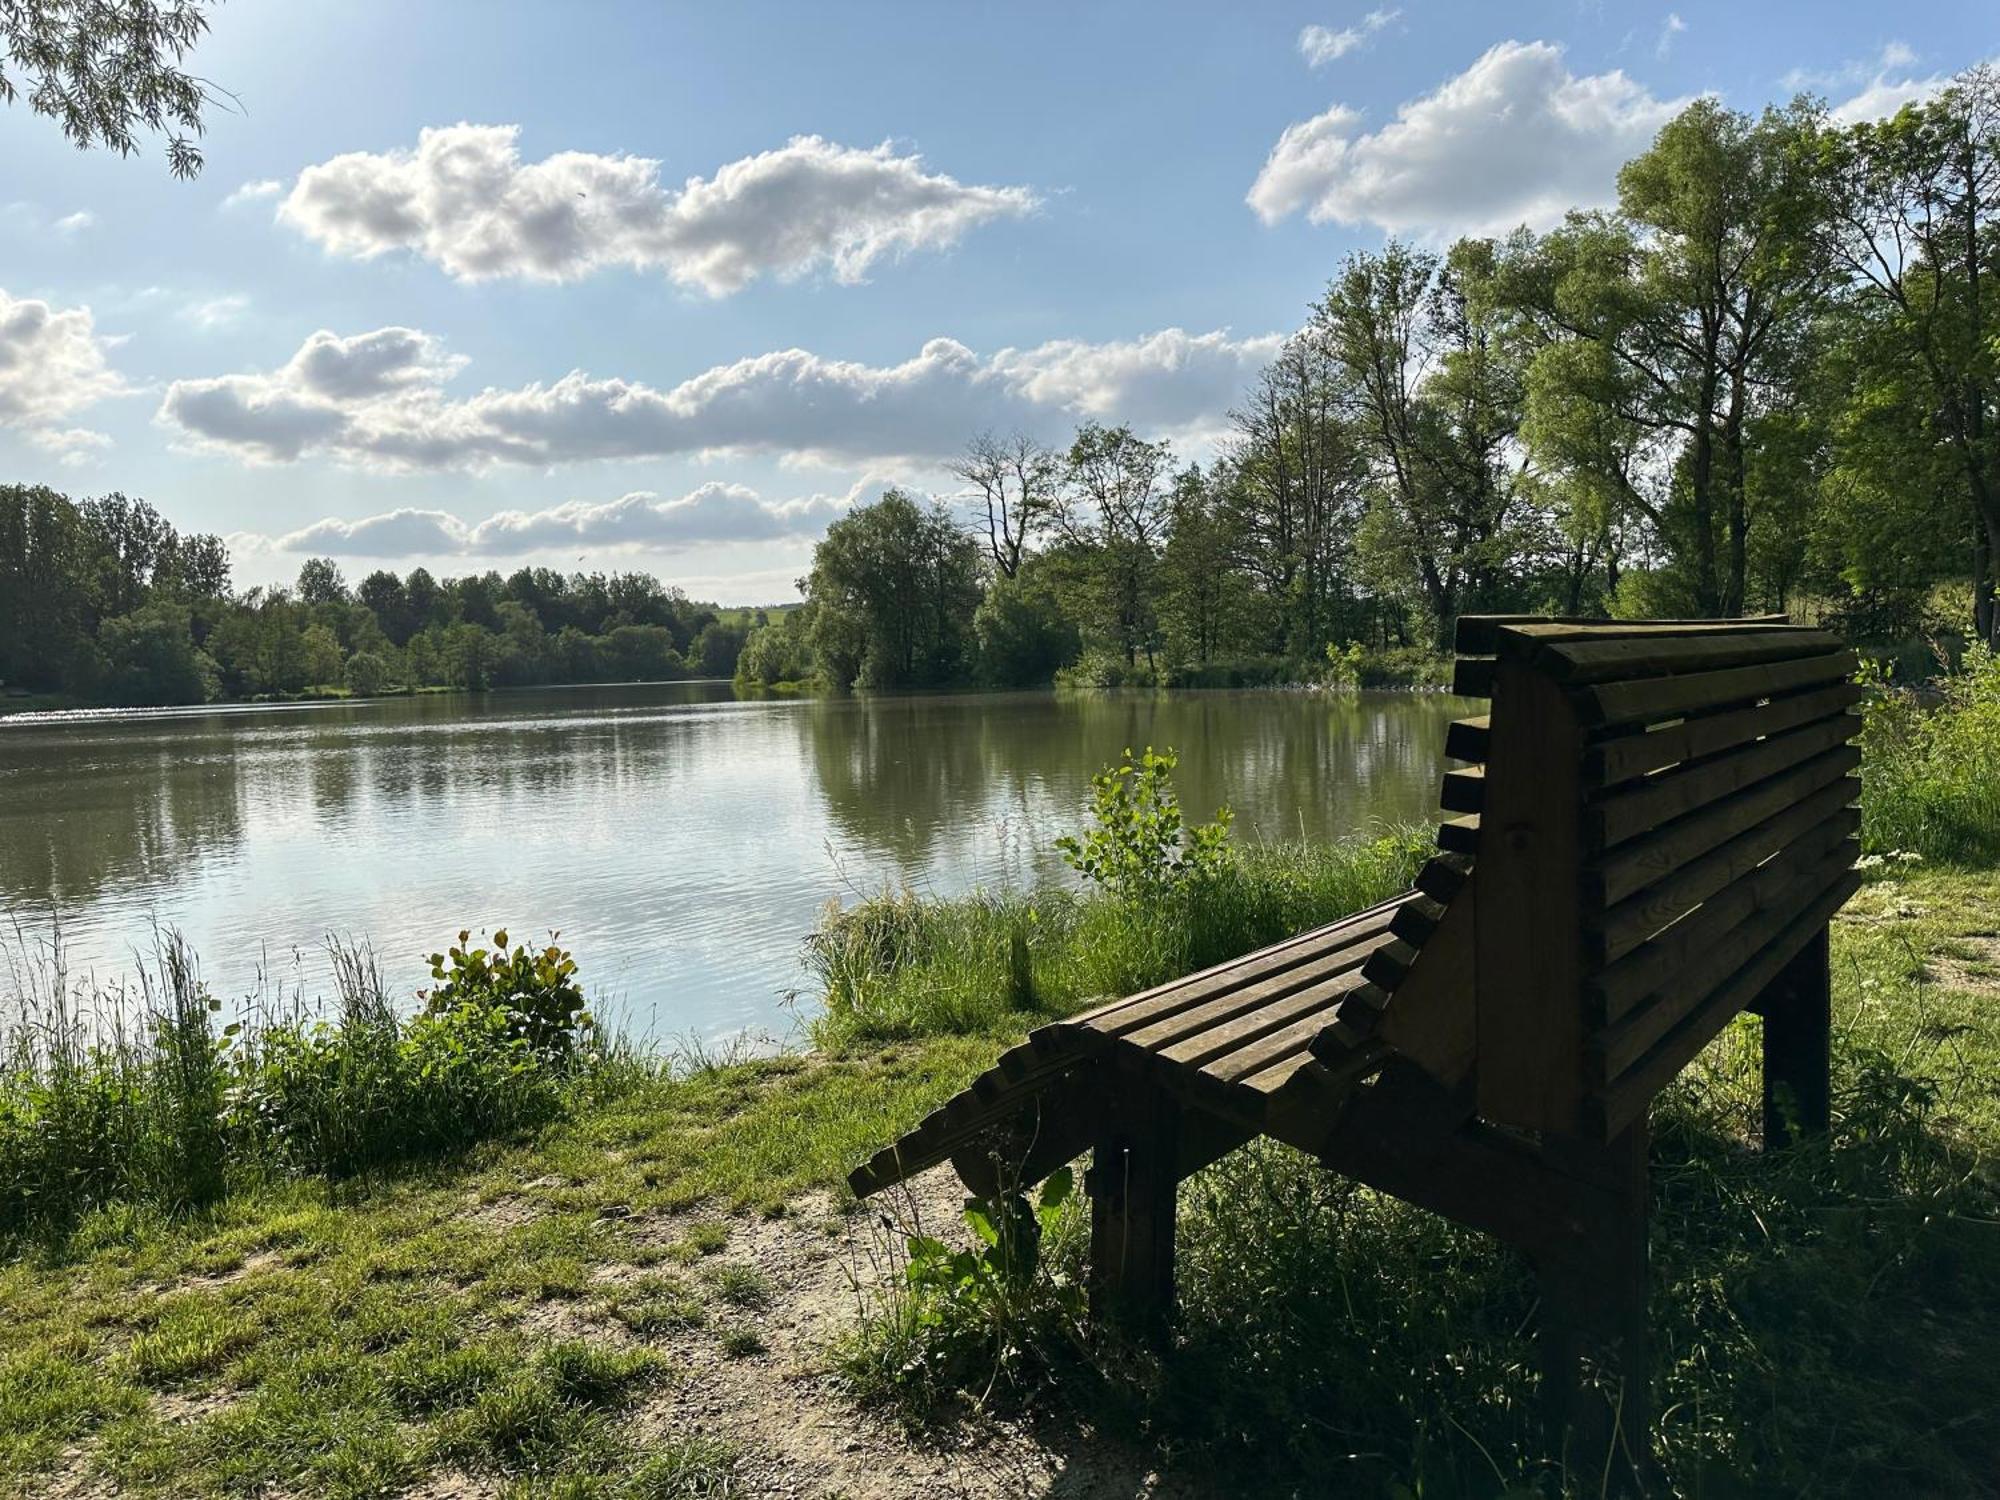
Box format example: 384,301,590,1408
1056,746,1234,904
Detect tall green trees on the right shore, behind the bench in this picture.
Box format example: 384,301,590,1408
742,68,2000,686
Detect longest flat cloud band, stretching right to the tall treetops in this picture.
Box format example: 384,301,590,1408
158,328,1280,470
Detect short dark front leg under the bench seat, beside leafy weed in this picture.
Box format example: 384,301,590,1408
1084,1090,1180,1338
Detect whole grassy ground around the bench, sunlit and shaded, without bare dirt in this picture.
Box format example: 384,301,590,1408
0,866,2000,1496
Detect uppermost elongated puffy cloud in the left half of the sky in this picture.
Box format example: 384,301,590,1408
268,124,1038,296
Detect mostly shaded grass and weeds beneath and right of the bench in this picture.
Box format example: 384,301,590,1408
840,870,2000,1496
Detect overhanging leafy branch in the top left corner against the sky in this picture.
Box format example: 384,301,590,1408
0,0,214,178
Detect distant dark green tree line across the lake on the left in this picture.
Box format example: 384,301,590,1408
0,486,744,704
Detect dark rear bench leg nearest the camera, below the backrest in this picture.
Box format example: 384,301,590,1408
1536,1122,1652,1488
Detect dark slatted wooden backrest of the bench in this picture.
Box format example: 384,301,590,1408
1446,616,1860,1138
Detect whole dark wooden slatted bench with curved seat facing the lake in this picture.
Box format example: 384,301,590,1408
850,616,1860,1456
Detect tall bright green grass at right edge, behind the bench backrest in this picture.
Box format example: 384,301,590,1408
1862,644,2000,866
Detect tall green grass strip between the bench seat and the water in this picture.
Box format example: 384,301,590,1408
806,828,1430,1046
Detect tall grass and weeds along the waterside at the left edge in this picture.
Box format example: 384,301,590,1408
0,930,640,1236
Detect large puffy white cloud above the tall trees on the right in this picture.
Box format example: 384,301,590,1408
1248,42,1688,238
